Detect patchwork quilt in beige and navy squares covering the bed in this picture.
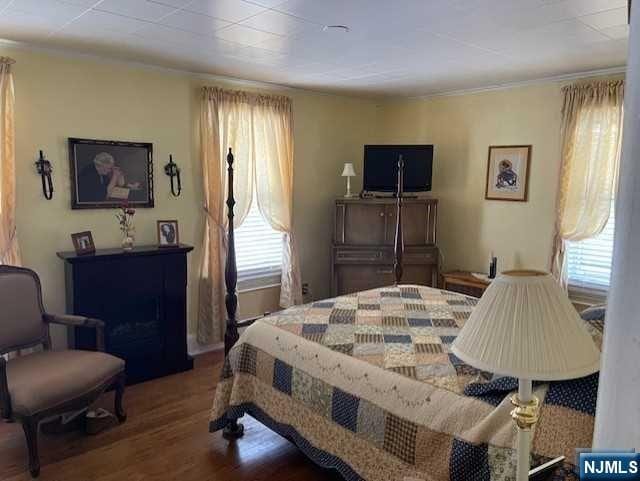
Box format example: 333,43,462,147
210,285,601,481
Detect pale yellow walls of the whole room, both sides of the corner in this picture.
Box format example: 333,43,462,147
0,42,616,348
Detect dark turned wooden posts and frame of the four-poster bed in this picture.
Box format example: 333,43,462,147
223,148,404,439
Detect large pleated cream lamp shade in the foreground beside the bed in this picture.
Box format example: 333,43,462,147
451,271,600,381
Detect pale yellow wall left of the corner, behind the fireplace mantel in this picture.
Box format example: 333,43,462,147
0,46,375,342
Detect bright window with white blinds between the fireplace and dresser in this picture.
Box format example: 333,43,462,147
235,196,283,290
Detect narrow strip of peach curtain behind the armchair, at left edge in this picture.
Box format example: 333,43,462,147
0,57,20,265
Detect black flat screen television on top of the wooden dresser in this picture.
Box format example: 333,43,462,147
363,145,433,192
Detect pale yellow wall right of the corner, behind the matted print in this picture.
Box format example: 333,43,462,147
377,83,562,272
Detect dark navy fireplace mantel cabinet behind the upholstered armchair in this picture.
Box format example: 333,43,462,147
58,245,193,383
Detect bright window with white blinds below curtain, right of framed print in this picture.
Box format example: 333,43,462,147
567,202,615,290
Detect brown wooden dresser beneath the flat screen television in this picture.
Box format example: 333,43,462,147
331,198,439,296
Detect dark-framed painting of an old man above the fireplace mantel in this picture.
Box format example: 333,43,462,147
68,137,153,209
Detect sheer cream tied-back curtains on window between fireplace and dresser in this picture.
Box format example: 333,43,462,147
197,87,302,344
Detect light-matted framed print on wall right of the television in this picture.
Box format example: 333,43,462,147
484,145,532,202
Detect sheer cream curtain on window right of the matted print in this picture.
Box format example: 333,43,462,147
551,80,624,288
